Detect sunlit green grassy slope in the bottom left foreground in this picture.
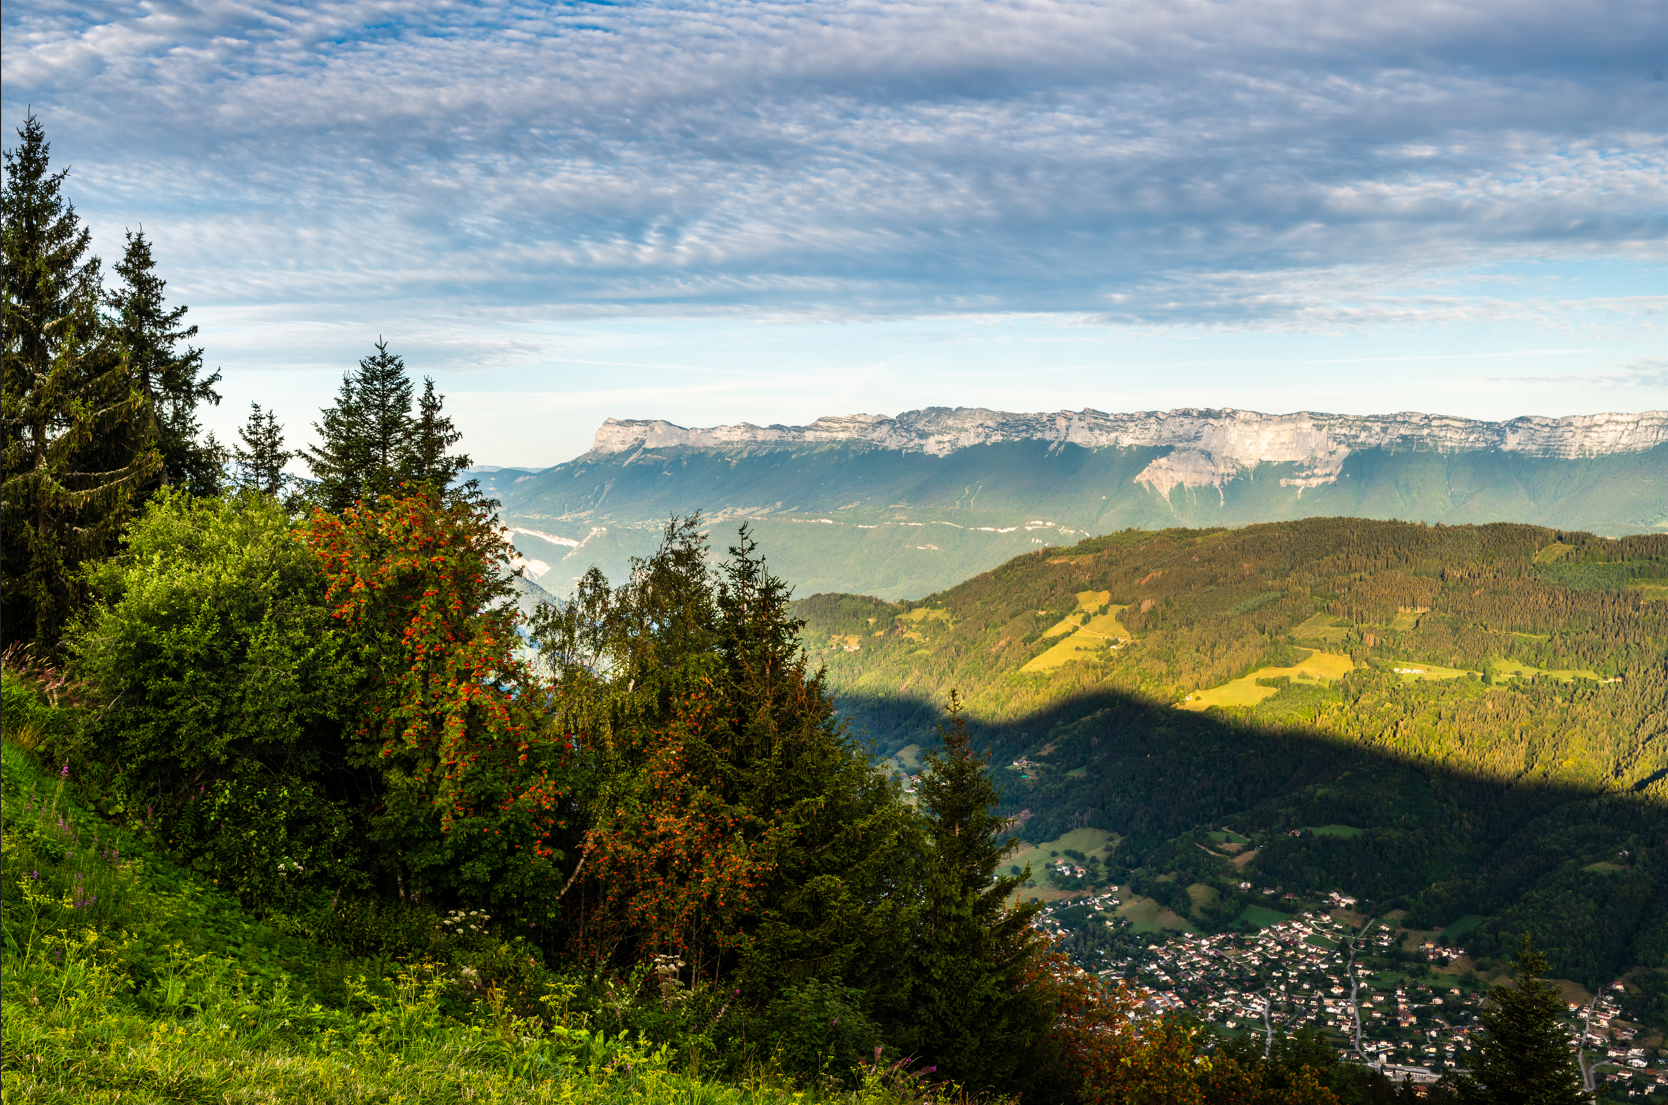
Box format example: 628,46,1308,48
0,739,944,1105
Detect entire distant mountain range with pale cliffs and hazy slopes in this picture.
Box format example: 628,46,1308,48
470,407,1668,599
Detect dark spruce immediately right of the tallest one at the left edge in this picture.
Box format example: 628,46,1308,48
107,229,225,494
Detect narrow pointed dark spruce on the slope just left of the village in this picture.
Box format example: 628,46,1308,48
887,693,1051,1088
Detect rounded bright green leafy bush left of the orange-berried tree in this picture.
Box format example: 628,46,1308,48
70,491,365,905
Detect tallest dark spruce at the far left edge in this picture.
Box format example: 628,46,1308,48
0,115,162,649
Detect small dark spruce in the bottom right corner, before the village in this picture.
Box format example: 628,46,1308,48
1456,936,1588,1105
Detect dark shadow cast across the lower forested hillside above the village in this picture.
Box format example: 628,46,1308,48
837,689,1668,985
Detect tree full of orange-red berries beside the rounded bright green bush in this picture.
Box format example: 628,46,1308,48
304,487,563,926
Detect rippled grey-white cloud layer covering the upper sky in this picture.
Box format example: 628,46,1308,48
3,0,1668,329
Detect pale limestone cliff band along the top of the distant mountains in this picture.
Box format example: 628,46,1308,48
590,407,1668,496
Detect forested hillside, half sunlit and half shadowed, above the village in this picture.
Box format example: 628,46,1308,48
797,519,1668,980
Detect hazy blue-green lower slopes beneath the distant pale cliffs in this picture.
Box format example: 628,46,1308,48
470,442,1668,598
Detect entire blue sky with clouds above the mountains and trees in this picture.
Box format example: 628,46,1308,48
0,0,1668,467
